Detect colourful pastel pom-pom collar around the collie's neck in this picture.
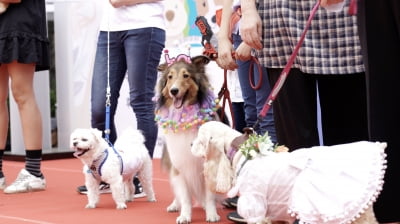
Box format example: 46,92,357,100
154,91,219,133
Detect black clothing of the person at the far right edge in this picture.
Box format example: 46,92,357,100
357,0,400,223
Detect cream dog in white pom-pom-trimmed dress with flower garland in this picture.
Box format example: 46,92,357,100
191,121,386,224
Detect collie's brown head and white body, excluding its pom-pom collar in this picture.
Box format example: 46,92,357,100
156,56,220,223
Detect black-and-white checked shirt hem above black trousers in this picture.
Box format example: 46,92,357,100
258,0,364,74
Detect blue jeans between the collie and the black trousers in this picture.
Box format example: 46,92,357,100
232,34,276,143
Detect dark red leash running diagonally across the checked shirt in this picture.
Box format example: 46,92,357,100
254,1,321,123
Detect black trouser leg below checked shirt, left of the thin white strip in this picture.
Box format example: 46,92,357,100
267,68,319,151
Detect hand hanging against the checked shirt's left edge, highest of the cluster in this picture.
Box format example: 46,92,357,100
240,5,262,50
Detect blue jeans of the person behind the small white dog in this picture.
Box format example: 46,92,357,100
91,27,165,156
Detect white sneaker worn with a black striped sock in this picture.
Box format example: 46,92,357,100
4,169,46,194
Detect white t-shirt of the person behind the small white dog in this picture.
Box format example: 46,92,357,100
100,0,165,31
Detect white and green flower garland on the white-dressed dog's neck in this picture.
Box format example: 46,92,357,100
239,132,288,159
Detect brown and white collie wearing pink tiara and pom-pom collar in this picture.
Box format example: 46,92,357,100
155,55,220,223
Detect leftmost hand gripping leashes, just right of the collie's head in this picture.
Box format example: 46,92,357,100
215,38,238,70
